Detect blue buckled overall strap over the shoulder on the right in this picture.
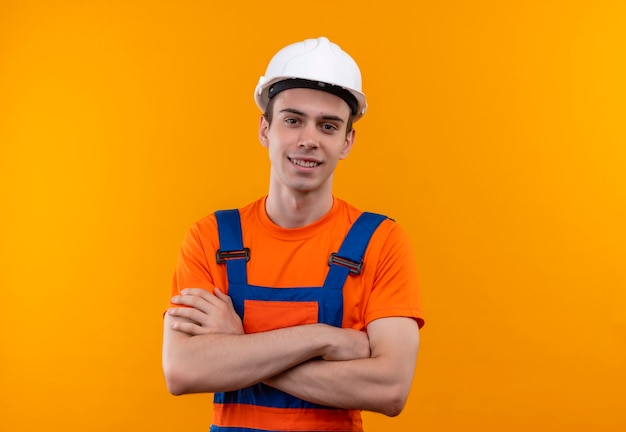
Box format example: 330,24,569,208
324,212,387,288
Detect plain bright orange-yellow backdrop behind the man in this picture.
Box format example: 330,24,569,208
0,0,626,432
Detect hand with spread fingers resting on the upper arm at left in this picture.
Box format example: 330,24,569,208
167,288,244,336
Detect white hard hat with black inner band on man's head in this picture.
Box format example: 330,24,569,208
254,37,367,122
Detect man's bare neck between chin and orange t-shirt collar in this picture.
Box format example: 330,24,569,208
265,187,333,228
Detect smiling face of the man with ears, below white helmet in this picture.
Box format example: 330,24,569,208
259,88,355,194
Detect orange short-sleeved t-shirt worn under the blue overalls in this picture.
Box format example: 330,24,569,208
172,198,424,330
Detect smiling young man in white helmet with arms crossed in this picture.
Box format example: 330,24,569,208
163,37,423,431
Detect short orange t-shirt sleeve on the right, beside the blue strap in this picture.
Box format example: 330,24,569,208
365,221,424,328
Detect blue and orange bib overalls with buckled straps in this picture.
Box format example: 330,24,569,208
211,210,386,432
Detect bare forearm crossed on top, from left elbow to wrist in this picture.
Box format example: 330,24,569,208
163,316,326,394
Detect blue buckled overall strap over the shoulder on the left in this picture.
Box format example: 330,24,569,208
215,210,250,284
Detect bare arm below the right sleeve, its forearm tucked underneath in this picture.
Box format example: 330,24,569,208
265,317,419,416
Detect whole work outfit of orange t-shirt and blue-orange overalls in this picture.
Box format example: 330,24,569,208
172,199,423,432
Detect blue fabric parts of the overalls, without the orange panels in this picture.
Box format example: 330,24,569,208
211,210,386,431
